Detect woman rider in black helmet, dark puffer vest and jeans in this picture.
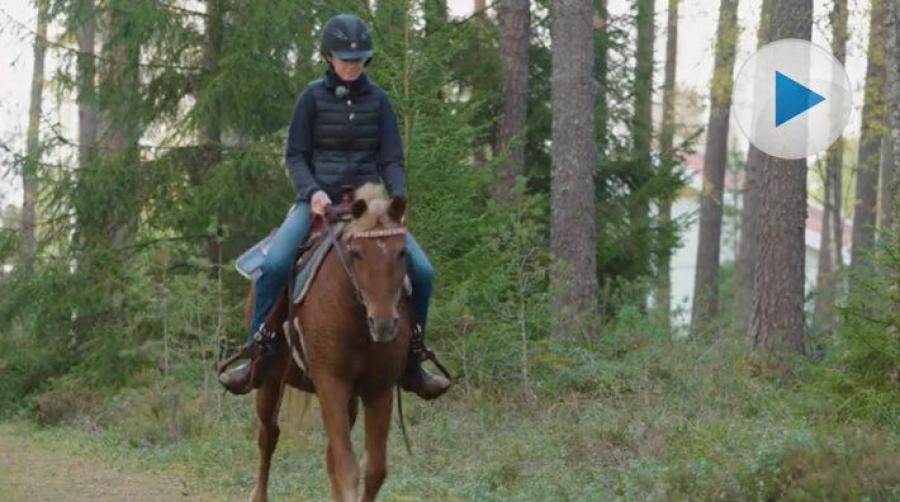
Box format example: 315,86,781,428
219,14,450,399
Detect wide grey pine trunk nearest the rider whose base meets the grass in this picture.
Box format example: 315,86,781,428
550,0,597,336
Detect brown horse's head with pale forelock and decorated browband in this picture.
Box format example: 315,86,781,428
343,186,406,342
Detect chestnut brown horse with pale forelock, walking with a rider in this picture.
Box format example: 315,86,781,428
248,190,412,502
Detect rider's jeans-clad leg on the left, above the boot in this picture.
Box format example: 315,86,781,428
246,202,310,345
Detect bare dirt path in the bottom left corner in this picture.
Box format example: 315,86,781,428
0,424,220,502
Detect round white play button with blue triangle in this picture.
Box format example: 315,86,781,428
732,39,852,159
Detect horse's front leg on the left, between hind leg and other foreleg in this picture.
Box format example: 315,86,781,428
316,378,359,502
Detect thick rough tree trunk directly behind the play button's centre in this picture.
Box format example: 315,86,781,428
749,0,813,364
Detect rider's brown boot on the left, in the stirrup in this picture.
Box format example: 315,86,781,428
219,323,276,395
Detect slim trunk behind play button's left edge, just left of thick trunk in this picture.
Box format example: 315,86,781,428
734,0,775,326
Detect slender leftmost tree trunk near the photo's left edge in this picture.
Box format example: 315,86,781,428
19,0,50,267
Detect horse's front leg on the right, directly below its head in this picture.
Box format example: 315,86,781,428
362,388,394,501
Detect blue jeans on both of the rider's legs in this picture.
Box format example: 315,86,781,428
245,202,434,345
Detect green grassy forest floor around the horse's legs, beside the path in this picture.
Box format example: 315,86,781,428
10,330,900,501
